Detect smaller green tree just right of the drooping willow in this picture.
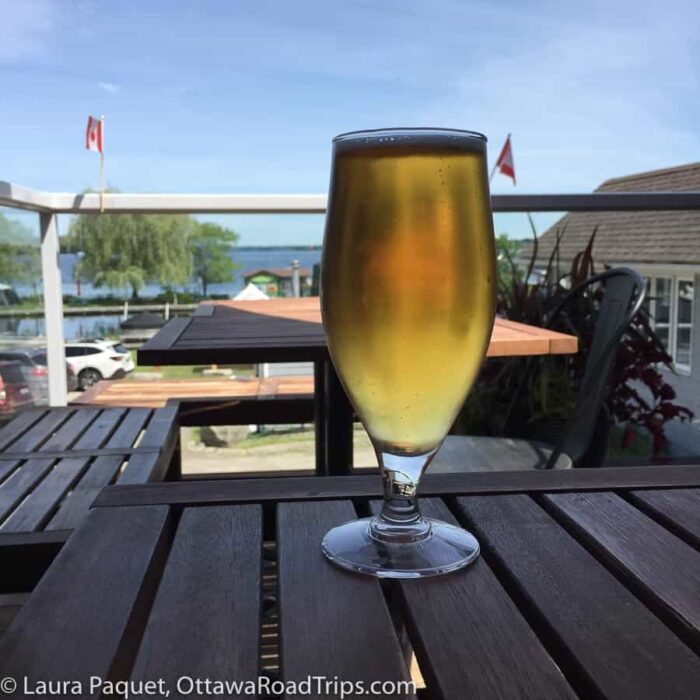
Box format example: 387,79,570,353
191,223,240,296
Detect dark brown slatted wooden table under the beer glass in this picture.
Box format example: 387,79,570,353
0,466,700,700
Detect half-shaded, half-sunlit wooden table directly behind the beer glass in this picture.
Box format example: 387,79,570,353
138,297,578,475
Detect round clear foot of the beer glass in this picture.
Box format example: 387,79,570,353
321,518,479,578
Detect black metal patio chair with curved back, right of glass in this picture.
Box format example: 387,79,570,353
430,267,646,474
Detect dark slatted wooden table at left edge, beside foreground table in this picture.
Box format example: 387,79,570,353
0,405,179,600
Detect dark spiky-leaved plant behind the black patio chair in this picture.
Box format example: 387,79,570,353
457,228,693,457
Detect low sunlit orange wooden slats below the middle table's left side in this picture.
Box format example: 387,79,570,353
72,377,314,408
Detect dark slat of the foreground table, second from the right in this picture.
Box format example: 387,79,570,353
543,493,700,651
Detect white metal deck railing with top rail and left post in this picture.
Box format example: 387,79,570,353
0,181,700,406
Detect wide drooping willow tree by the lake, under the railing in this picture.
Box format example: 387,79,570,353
67,208,197,298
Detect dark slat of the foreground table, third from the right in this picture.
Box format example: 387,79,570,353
457,495,700,700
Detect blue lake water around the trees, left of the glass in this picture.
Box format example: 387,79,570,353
0,248,321,340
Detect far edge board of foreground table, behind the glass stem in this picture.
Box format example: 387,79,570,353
93,465,700,507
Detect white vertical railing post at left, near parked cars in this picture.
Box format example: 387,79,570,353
39,212,68,406
